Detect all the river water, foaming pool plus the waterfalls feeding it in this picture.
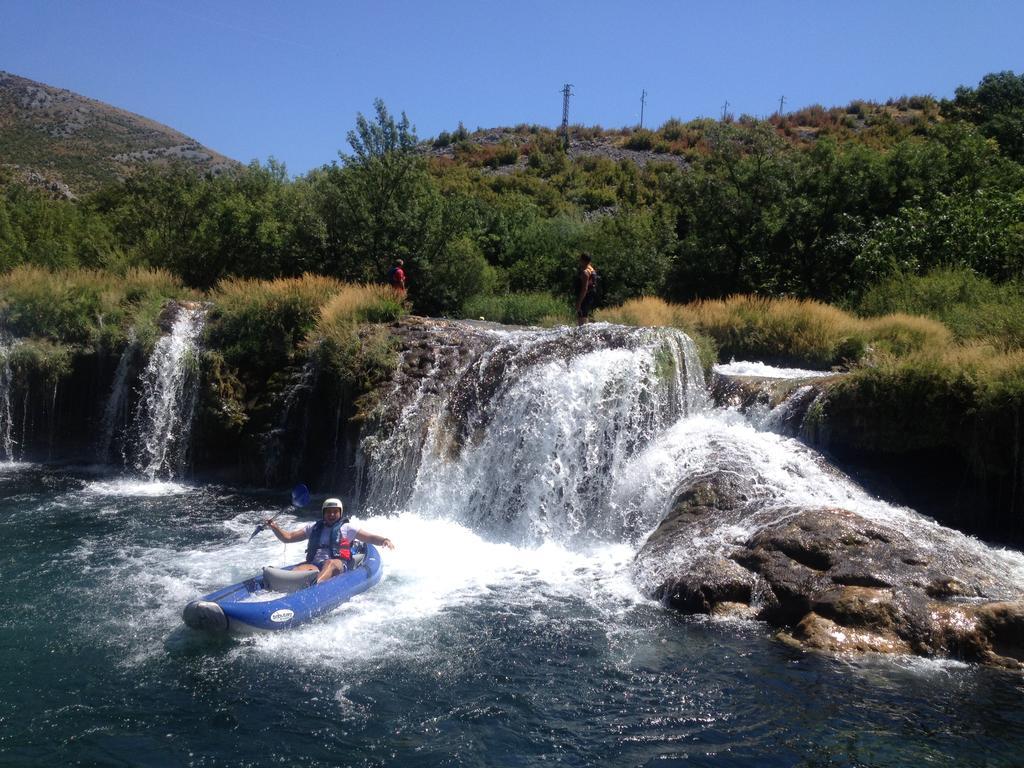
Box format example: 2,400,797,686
0,321,1024,766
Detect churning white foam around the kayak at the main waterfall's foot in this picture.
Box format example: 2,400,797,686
97,513,646,666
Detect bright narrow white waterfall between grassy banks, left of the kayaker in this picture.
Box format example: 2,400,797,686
125,306,206,480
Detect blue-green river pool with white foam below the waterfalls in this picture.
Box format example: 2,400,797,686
0,465,1024,766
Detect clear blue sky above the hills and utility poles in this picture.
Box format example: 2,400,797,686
0,0,1024,174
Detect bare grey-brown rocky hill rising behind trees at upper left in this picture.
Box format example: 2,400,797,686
0,72,237,196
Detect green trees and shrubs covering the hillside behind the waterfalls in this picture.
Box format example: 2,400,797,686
0,73,1024,347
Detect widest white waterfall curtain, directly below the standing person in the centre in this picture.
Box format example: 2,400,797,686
360,325,707,542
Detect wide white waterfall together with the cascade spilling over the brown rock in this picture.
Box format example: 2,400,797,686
361,327,1024,582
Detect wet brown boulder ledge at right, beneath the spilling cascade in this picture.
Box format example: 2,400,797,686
635,467,1024,670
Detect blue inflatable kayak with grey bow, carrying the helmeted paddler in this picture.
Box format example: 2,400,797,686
181,544,382,634
